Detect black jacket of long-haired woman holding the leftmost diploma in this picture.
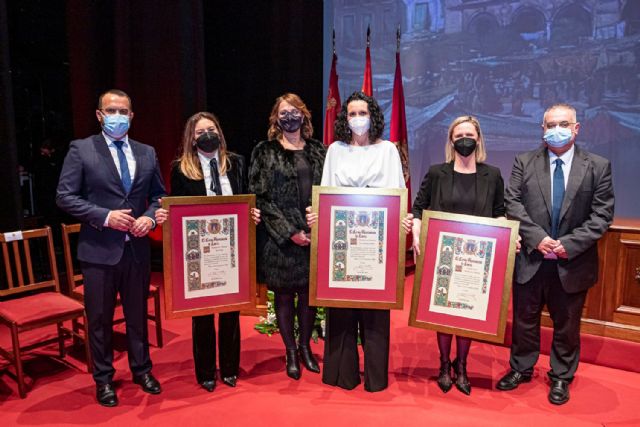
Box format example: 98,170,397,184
171,152,247,196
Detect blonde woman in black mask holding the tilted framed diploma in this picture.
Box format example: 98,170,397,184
413,116,505,395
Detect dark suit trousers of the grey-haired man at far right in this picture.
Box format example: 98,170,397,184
510,260,587,381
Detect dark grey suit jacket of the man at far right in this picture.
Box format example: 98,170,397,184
506,146,614,293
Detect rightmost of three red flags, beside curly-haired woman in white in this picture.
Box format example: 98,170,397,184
389,44,412,249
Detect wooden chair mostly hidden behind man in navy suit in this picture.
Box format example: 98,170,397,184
62,224,163,348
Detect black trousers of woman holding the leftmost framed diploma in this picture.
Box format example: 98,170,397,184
191,311,240,383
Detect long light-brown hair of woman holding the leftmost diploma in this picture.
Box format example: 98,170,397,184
176,111,231,180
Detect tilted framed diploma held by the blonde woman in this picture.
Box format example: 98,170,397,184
409,210,519,343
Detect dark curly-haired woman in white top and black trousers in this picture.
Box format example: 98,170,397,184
318,92,412,392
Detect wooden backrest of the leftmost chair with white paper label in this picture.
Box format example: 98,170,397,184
0,226,60,296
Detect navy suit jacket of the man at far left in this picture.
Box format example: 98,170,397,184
56,134,165,265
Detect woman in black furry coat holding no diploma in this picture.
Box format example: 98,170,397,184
249,93,325,380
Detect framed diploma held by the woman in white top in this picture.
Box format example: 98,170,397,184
309,186,407,309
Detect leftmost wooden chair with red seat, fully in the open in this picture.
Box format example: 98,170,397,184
0,227,92,399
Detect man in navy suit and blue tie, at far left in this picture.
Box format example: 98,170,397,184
56,89,165,406
